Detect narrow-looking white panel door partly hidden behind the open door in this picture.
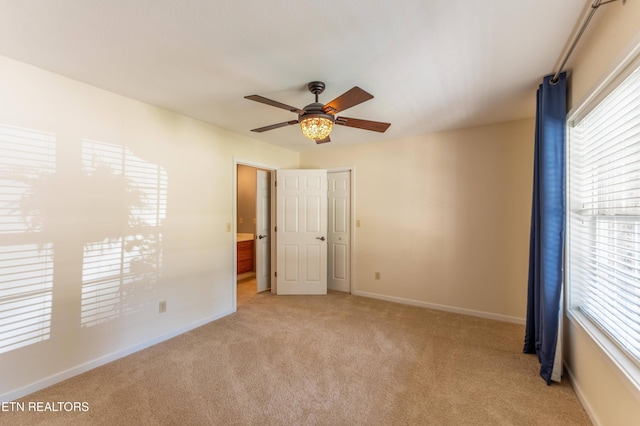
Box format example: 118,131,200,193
327,171,351,292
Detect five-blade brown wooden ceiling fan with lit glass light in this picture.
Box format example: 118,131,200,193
245,81,391,144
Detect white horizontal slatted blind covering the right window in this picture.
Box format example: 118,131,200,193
568,68,640,364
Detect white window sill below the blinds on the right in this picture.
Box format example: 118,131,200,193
567,310,640,402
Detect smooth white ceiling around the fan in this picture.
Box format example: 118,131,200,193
0,0,591,151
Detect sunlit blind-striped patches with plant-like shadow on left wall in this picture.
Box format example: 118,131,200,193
0,125,167,354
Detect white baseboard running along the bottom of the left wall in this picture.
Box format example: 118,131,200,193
0,310,235,402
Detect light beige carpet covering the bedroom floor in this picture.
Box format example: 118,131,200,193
0,291,590,426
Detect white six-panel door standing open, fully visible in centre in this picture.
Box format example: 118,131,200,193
276,170,327,294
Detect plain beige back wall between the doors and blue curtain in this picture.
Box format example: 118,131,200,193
300,119,535,322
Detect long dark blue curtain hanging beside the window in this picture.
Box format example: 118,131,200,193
524,73,567,384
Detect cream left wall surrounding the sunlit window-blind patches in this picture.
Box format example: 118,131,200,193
0,57,299,401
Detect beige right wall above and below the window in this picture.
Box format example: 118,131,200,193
564,0,640,425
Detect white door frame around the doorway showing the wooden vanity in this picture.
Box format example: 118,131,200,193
231,157,278,312
